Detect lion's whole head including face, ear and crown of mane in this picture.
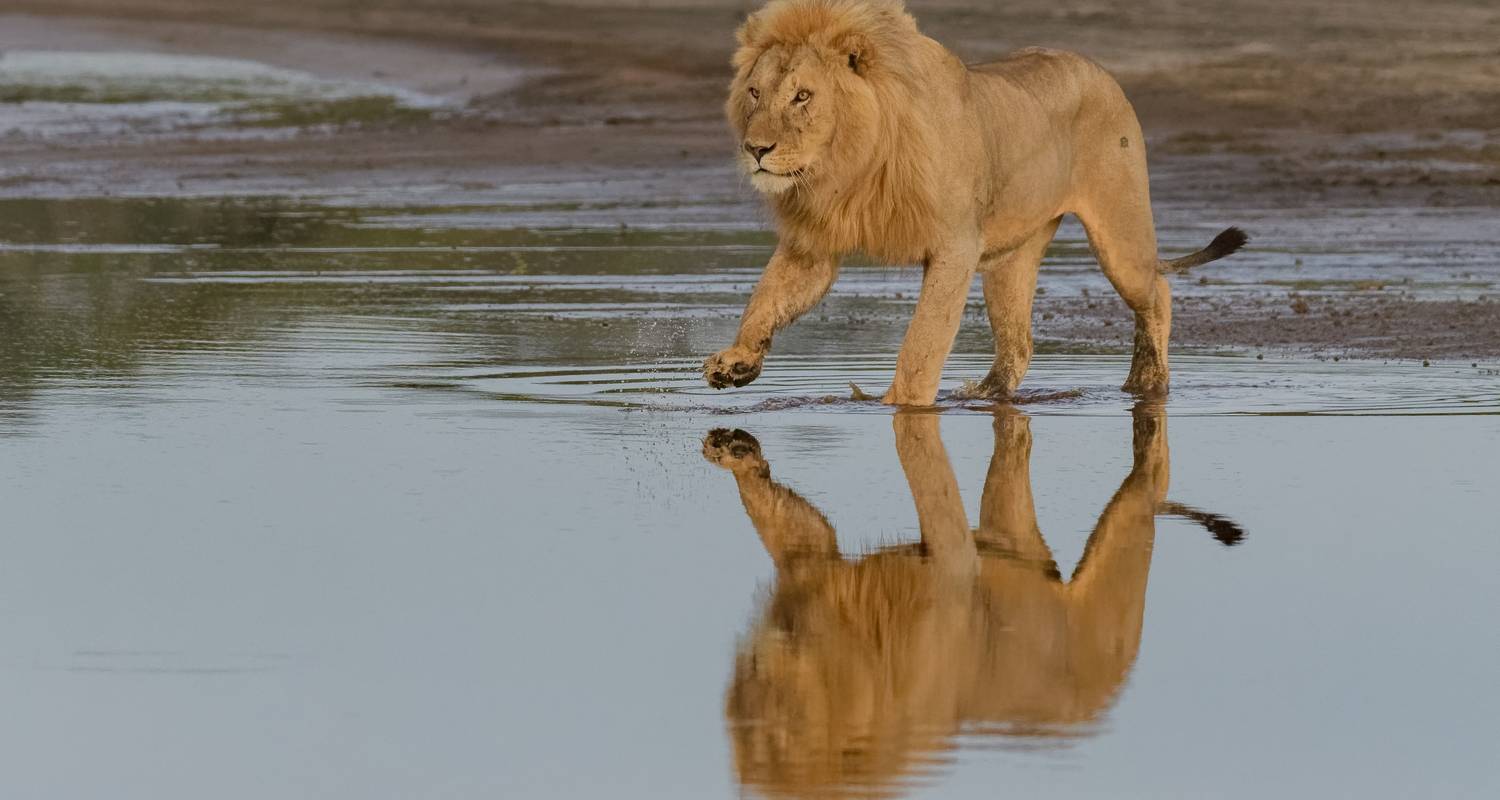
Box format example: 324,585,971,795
725,0,917,195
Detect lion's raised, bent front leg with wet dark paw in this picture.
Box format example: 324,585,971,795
704,248,839,389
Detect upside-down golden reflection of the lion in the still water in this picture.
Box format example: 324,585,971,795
704,410,1241,795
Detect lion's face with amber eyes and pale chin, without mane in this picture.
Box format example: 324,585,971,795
726,47,861,194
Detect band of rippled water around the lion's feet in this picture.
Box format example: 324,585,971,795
393,354,1500,416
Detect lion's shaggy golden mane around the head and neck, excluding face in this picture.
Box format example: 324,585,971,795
729,0,948,263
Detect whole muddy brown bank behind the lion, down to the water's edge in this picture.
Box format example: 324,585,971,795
0,0,1500,359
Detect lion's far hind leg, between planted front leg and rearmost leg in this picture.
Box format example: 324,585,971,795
980,218,1062,398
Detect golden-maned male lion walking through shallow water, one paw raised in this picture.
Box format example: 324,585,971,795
704,0,1247,405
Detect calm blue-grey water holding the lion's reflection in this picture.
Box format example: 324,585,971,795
0,197,1500,800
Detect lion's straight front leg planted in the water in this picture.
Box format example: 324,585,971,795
881,240,980,405
